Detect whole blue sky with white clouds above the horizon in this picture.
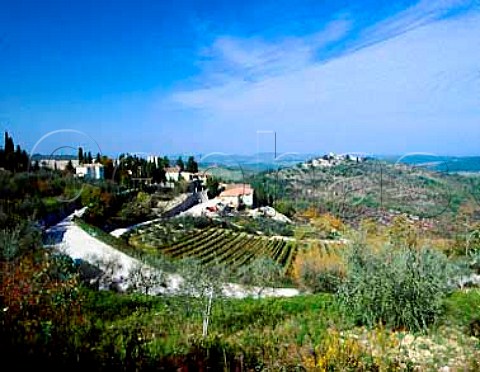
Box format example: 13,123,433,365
0,0,480,155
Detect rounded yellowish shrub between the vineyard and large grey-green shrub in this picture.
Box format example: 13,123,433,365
293,245,345,293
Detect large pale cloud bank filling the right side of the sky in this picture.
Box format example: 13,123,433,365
165,1,480,152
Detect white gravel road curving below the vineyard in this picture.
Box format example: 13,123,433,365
47,210,299,298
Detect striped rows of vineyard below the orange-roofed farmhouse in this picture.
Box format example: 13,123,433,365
129,227,297,271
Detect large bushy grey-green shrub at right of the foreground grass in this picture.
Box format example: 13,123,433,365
338,246,457,331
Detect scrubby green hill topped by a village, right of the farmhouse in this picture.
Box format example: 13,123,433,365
266,157,480,230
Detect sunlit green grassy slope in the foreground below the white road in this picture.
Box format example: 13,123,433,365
87,291,480,370
